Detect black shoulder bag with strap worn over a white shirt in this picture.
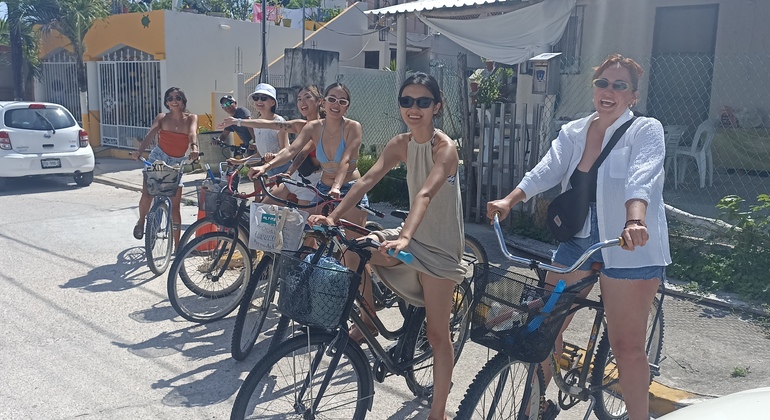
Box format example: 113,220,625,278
546,117,636,242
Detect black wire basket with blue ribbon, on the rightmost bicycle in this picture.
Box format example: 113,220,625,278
471,264,577,363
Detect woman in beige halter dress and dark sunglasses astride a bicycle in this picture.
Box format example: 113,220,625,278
309,73,465,419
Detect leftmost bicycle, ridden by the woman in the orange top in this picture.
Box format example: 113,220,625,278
139,157,195,276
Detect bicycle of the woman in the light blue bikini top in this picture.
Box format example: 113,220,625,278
230,177,390,360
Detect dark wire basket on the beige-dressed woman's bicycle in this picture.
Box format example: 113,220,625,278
278,252,361,329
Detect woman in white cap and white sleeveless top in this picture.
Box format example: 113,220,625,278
227,83,289,175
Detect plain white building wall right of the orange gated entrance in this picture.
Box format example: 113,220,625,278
164,11,301,114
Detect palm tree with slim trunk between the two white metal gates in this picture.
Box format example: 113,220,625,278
27,0,110,120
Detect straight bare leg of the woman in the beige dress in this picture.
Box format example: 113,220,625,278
421,273,455,419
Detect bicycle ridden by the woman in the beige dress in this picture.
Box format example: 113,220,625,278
230,226,464,419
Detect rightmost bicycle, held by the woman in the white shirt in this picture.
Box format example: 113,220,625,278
457,216,665,420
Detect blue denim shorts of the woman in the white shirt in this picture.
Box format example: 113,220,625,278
552,203,665,280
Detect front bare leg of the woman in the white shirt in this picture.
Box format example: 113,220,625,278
600,275,660,420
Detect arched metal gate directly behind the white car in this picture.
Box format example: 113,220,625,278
42,50,83,123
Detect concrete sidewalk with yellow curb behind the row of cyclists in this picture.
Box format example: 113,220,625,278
94,157,770,415
